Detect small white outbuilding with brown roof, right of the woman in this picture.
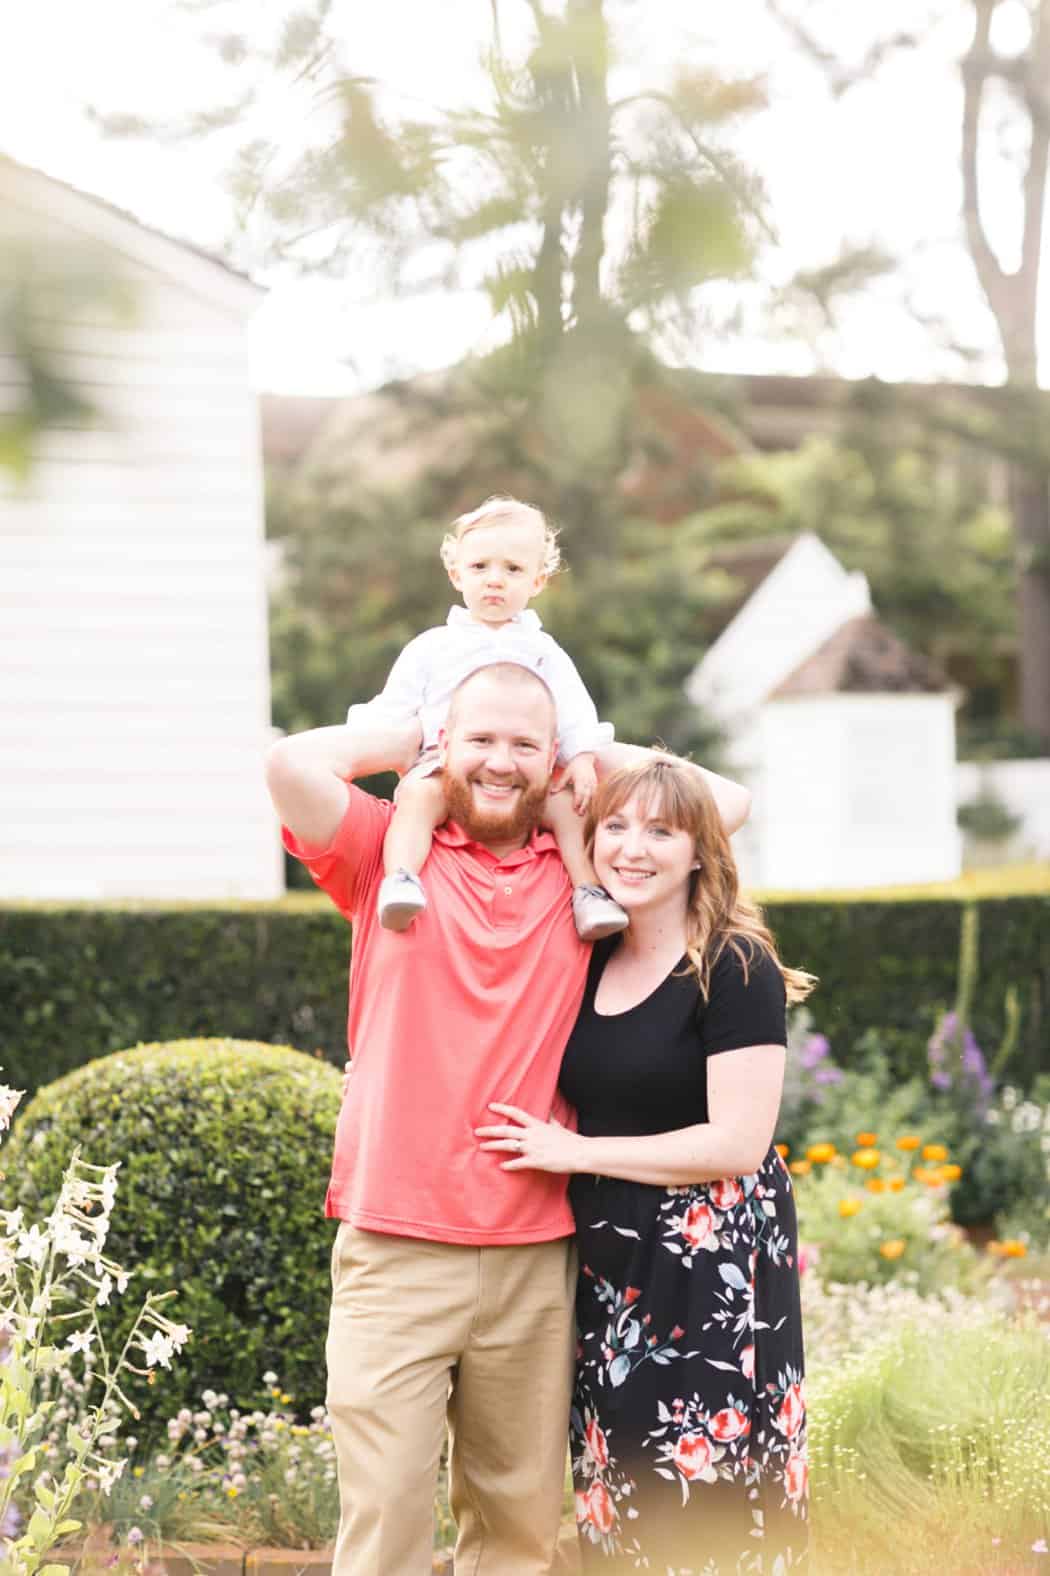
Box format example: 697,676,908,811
687,534,960,890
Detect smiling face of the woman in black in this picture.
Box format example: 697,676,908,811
594,796,697,913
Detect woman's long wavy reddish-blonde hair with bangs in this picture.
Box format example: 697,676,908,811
586,755,817,1002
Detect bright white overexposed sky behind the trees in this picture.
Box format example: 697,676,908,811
0,0,1027,394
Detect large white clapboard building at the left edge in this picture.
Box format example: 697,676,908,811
0,159,282,900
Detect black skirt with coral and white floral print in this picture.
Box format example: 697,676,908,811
571,1149,807,1576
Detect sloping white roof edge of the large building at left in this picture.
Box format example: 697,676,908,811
0,153,265,314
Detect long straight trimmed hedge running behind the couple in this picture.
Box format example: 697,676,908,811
0,894,1050,1089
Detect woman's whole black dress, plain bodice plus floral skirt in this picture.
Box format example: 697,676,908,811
561,941,807,1576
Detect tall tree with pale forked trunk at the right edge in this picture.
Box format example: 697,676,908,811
766,0,1050,749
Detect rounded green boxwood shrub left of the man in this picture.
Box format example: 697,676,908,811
3,1039,341,1437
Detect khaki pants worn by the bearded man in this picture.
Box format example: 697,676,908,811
326,1221,575,1576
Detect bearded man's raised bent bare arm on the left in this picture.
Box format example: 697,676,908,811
266,720,419,851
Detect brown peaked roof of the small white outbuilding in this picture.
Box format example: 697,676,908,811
769,615,951,700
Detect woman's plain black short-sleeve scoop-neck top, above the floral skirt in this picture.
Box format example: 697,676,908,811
560,939,787,1138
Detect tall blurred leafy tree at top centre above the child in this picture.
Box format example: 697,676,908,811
106,0,765,535
